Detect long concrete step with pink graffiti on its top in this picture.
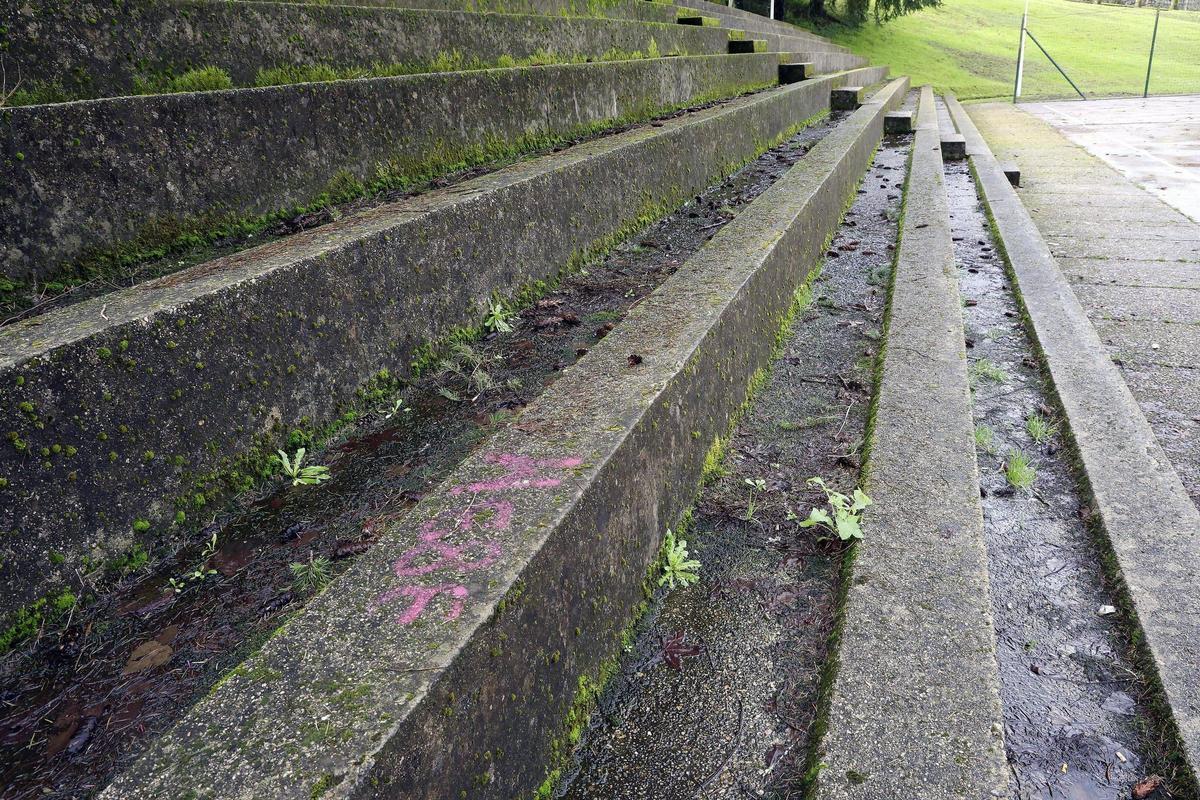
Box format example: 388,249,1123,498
101,79,907,800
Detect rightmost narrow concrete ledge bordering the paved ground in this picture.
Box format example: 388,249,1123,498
946,96,1200,784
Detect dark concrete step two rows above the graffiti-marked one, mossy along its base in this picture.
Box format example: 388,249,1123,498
0,54,778,287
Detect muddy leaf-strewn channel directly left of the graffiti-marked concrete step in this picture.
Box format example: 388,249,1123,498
0,118,836,800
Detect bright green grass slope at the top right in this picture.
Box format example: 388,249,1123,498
792,0,1200,100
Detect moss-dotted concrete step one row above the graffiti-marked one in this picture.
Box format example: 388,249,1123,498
0,64,884,608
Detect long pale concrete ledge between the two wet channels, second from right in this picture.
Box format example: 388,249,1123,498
814,86,1008,800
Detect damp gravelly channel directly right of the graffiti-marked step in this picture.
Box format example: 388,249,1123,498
556,138,908,800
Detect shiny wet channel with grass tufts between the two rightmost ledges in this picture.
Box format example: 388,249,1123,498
946,162,1169,800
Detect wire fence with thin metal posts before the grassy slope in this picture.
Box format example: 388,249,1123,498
1012,0,1200,100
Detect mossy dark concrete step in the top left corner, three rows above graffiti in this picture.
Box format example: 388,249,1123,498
0,0,727,100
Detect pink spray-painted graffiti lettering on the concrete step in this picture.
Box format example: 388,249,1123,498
372,453,583,625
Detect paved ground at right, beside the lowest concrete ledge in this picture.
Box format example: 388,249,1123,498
967,97,1200,504
